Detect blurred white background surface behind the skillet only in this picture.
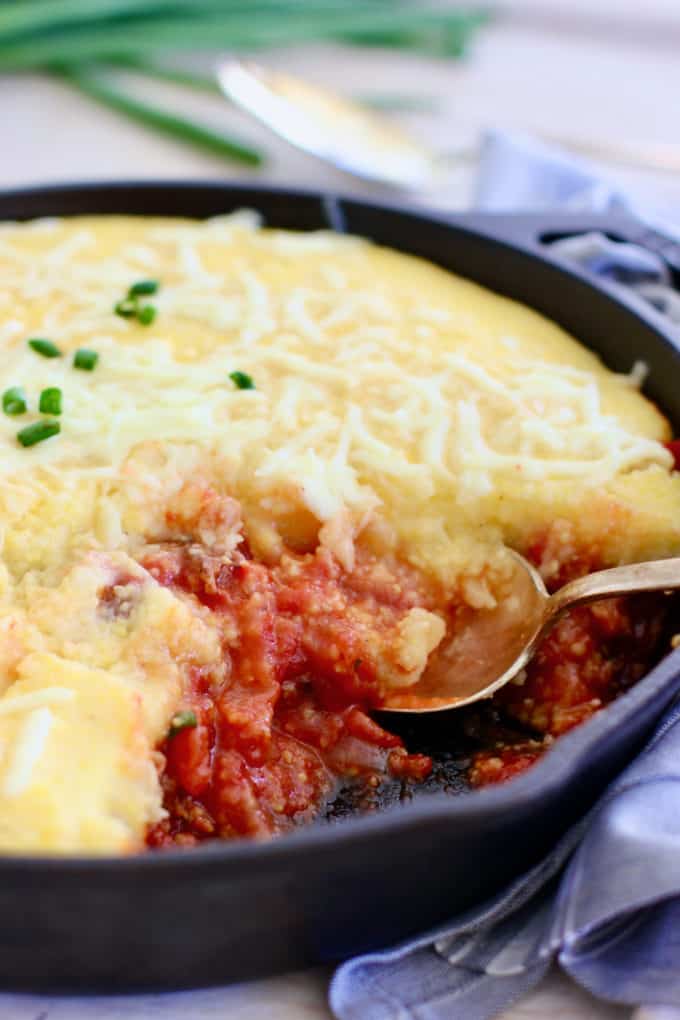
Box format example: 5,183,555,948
5,0,680,218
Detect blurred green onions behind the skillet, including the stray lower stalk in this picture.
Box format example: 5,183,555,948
0,0,488,166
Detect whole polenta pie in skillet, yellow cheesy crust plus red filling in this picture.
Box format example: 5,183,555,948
0,212,680,854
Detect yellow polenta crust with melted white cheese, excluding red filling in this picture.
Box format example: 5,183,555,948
0,213,680,852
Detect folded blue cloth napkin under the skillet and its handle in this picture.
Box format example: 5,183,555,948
330,133,680,1020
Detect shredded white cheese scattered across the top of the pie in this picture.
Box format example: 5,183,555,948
0,217,670,509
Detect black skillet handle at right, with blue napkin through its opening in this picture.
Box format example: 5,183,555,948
452,212,680,290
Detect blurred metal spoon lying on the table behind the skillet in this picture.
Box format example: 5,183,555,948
217,59,680,195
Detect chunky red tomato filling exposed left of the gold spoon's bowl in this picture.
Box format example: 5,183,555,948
144,545,433,847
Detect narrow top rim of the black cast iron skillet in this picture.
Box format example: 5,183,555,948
0,179,680,878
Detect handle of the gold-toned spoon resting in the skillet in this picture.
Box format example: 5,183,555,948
548,556,680,617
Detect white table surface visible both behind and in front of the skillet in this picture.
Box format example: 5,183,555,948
0,0,680,1020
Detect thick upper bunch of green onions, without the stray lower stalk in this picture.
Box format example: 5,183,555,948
0,0,485,70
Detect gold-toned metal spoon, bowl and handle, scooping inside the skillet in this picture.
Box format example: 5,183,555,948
380,553,680,713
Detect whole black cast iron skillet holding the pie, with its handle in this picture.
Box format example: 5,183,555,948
0,183,680,990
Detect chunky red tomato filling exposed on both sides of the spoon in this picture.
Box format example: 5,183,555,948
143,514,665,847
